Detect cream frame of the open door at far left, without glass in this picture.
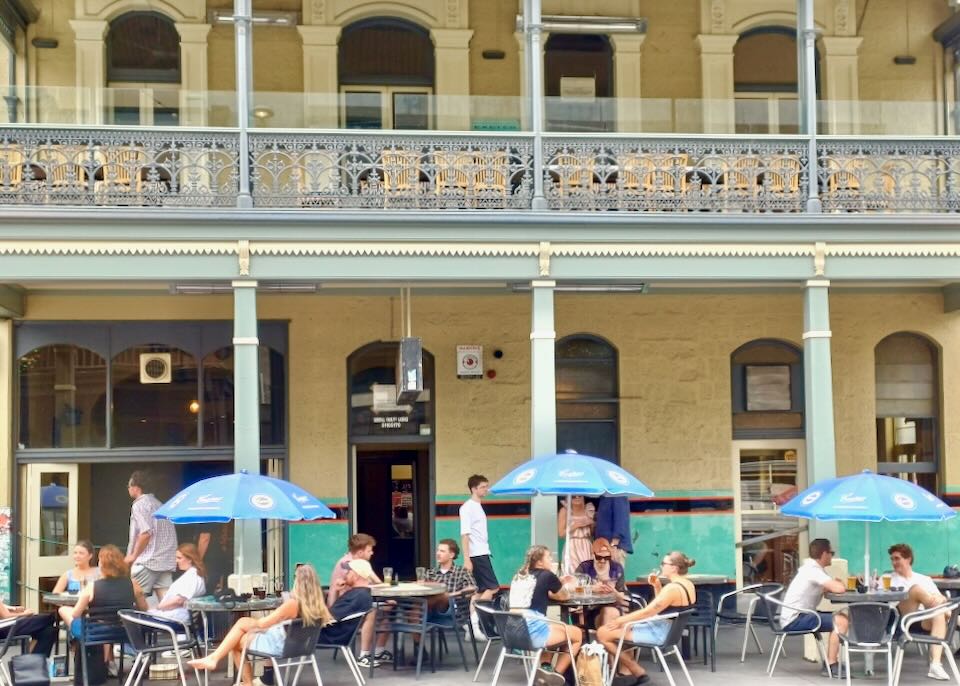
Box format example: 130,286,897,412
21,462,80,609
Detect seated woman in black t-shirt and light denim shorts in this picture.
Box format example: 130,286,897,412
518,545,583,686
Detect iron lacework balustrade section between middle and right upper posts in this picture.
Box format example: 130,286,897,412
544,137,808,212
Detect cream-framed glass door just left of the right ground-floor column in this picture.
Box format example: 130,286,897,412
731,439,807,586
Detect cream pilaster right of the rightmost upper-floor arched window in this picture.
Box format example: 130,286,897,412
820,36,863,134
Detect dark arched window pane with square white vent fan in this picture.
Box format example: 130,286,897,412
111,344,200,448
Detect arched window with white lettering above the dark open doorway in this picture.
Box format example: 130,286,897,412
347,342,434,440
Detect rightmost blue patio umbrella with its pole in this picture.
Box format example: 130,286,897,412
780,469,957,576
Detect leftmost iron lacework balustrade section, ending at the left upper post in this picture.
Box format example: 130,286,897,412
0,128,239,207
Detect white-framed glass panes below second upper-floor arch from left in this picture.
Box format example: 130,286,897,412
340,85,433,131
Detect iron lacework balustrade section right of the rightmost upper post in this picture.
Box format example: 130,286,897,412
817,139,960,212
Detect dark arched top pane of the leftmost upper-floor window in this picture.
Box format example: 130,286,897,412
107,12,180,83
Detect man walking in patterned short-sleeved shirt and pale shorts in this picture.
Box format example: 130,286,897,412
123,471,177,599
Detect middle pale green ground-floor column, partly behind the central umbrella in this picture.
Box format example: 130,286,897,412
530,281,559,559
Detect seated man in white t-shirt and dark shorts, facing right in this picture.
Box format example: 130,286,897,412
780,538,849,676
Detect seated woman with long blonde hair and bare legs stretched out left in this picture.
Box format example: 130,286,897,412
187,564,332,686
